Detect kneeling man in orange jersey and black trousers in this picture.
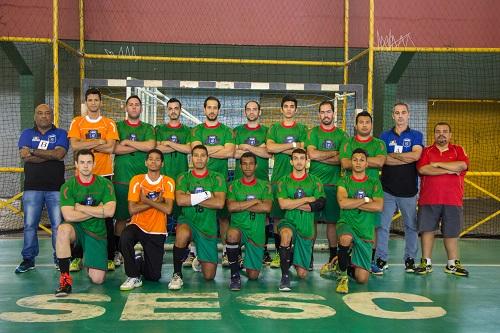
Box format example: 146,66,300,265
120,149,175,291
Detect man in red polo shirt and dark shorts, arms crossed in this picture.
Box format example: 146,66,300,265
415,122,469,276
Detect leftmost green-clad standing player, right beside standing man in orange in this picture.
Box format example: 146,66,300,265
113,95,155,266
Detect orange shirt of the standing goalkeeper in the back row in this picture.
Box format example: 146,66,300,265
68,116,119,176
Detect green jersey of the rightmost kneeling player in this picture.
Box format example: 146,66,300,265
337,175,384,240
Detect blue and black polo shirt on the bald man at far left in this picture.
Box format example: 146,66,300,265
18,126,69,191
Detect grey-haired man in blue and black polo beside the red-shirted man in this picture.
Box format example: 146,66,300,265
375,103,423,273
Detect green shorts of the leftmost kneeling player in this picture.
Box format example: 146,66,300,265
69,222,108,271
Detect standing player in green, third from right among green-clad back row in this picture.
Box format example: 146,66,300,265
266,95,307,268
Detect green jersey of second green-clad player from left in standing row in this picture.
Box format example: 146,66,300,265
155,124,191,179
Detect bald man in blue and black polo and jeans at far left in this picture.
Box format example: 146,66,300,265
15,104,69,273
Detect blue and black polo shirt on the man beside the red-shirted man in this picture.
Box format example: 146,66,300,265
380,127,424,197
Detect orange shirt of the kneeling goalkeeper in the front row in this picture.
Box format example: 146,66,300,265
128,174,175,234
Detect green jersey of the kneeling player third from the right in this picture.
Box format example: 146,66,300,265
227,178,273,246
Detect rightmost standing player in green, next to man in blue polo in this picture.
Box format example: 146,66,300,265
340,111,387,275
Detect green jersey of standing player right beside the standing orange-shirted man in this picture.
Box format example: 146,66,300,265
113,120,155,184
